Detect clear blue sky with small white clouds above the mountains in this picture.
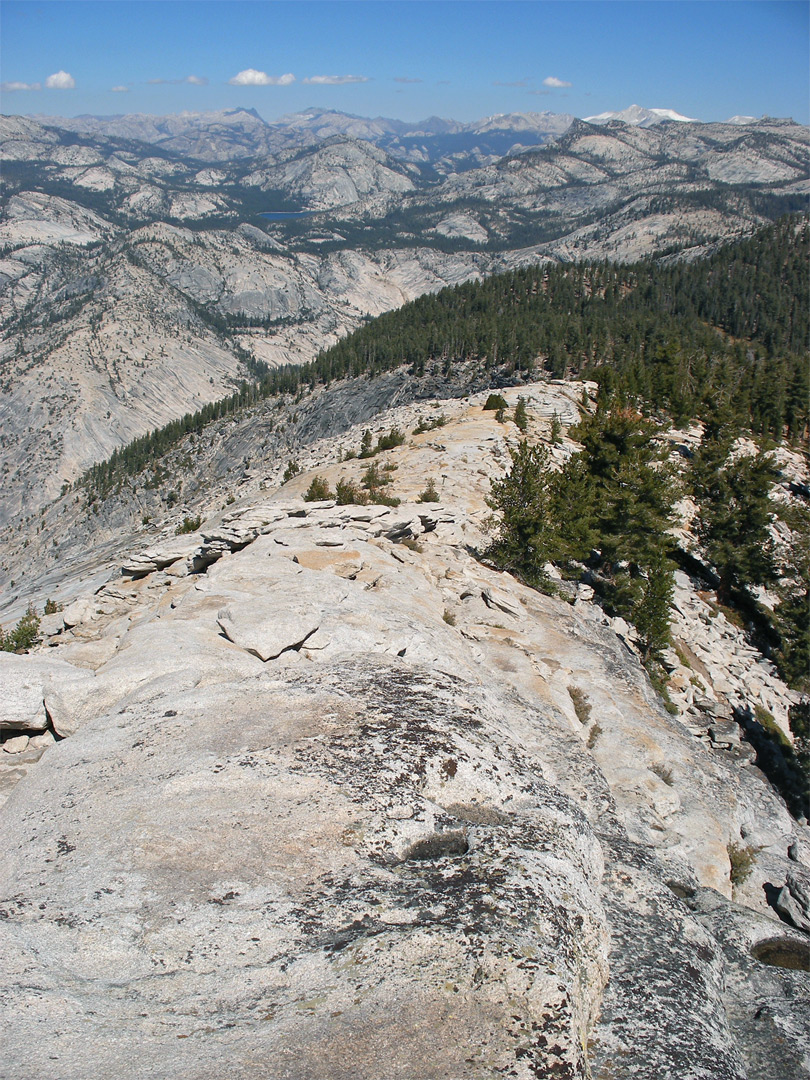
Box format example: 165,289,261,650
0,0,810,123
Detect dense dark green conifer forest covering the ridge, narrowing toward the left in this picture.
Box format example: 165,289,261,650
80,215,810,496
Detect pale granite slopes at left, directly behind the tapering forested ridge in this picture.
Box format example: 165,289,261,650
0,206,494,525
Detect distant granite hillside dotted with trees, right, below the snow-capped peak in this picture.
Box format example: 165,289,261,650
432,121,810,260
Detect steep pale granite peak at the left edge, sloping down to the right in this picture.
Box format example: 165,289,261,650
0,228,252,524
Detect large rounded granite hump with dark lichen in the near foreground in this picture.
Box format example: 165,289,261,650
3,659,606,1080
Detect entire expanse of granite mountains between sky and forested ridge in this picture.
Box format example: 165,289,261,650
0,112,810,525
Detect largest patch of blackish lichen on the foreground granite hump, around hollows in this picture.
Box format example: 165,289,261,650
234,659,604,1078
